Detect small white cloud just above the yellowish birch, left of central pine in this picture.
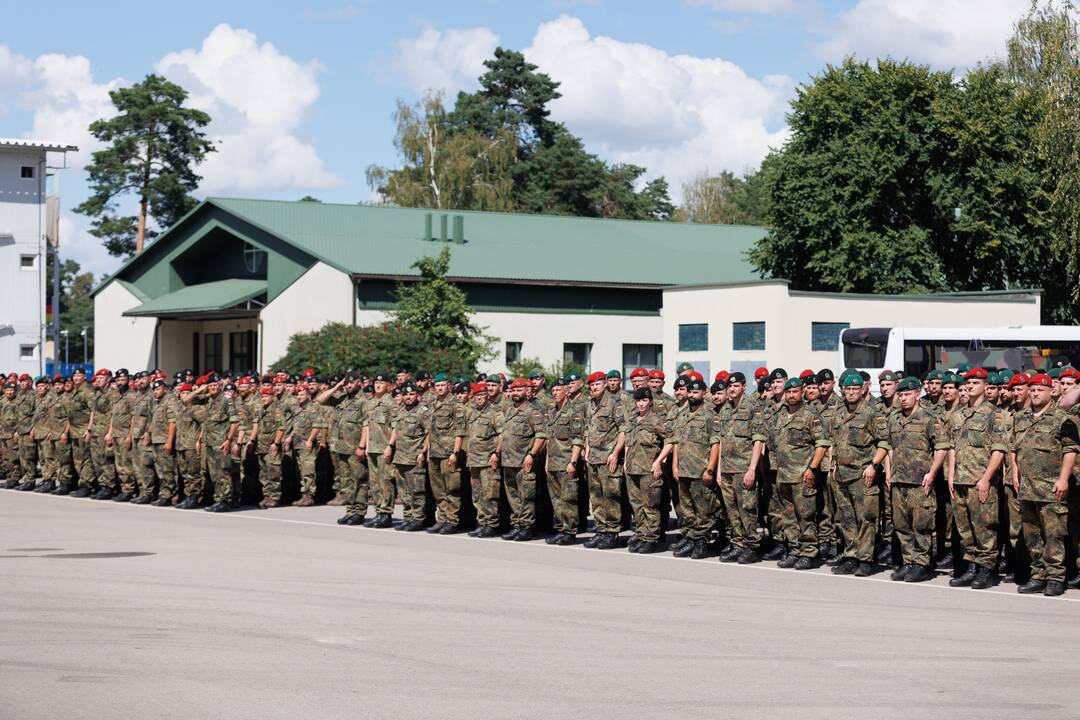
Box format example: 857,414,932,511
395,27,499,97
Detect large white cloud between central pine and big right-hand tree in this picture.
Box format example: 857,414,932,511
525,15,795,190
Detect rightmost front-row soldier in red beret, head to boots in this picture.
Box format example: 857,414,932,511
1011,373,1080,596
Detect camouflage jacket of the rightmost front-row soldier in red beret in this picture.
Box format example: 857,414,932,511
1012,406,1080,502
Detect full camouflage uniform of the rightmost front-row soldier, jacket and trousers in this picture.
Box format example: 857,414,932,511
1012,406,1080,583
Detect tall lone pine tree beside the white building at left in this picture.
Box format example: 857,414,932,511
75,74,215,257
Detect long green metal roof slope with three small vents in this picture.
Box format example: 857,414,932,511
203,198,768,285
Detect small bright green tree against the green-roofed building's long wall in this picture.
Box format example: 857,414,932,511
390,247,495,368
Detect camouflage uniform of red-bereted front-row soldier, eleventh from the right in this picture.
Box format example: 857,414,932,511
499,400,548,530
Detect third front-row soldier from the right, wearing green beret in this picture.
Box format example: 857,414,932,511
888,377,953,583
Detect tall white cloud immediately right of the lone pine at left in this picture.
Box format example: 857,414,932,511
156,24,341,194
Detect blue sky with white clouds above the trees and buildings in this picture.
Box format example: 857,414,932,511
0,0,1027,273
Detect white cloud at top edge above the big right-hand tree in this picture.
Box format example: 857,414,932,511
818,0,1030,70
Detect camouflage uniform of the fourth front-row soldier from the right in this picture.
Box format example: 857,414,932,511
827,400,889,562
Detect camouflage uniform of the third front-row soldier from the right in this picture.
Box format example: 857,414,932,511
888,406,953,567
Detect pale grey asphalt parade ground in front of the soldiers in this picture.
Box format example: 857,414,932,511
0,491,1080,720
